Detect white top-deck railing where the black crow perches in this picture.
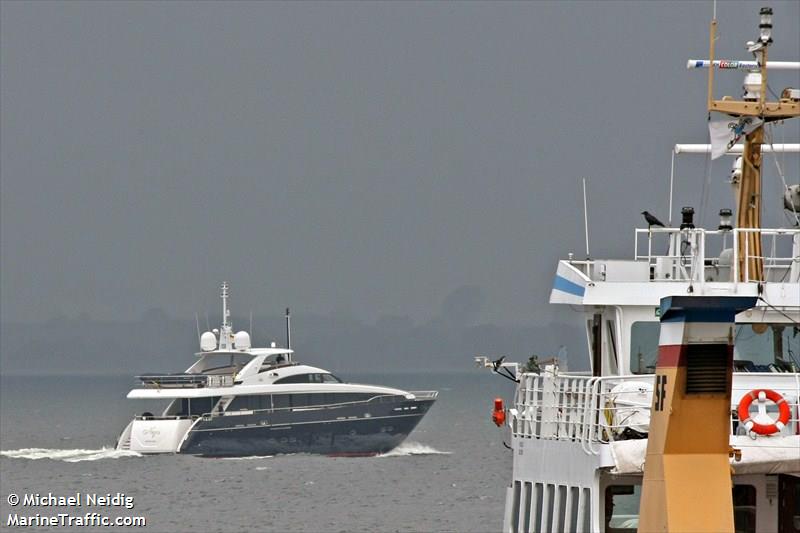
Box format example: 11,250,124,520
632,228,800,283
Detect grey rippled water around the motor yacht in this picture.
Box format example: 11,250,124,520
0,370,513,532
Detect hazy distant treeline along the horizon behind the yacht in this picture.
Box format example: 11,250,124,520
0,309,588,375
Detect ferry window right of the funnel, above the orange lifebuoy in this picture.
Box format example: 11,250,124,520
733,322,800,372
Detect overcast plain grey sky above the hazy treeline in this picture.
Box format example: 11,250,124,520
0,0,800,325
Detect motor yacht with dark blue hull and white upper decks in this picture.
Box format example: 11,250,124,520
117,283,438,457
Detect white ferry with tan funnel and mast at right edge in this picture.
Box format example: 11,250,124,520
476,8,800,533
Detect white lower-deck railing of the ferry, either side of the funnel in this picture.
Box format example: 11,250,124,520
508,373,800,455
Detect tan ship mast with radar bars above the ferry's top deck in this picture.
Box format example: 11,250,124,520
704,7,800,281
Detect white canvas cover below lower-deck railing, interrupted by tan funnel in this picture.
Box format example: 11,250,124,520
611,435,800,474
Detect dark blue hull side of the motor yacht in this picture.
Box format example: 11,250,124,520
180,400,433,457
